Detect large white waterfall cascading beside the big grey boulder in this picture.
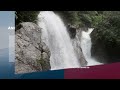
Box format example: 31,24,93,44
38,11,80,70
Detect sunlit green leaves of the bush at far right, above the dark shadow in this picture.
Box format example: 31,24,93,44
95,11,120,45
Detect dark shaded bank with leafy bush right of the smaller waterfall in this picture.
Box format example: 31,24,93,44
91,11,120,63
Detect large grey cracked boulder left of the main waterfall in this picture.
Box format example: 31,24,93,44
15,22,50,73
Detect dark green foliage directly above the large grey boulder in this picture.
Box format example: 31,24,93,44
15,11,39,25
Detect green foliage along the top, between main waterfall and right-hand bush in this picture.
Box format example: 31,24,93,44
57,11,103,27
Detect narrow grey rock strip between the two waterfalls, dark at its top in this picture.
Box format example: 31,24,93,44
68,26,88,66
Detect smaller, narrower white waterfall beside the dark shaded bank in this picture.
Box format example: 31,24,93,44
81,28,102,66
